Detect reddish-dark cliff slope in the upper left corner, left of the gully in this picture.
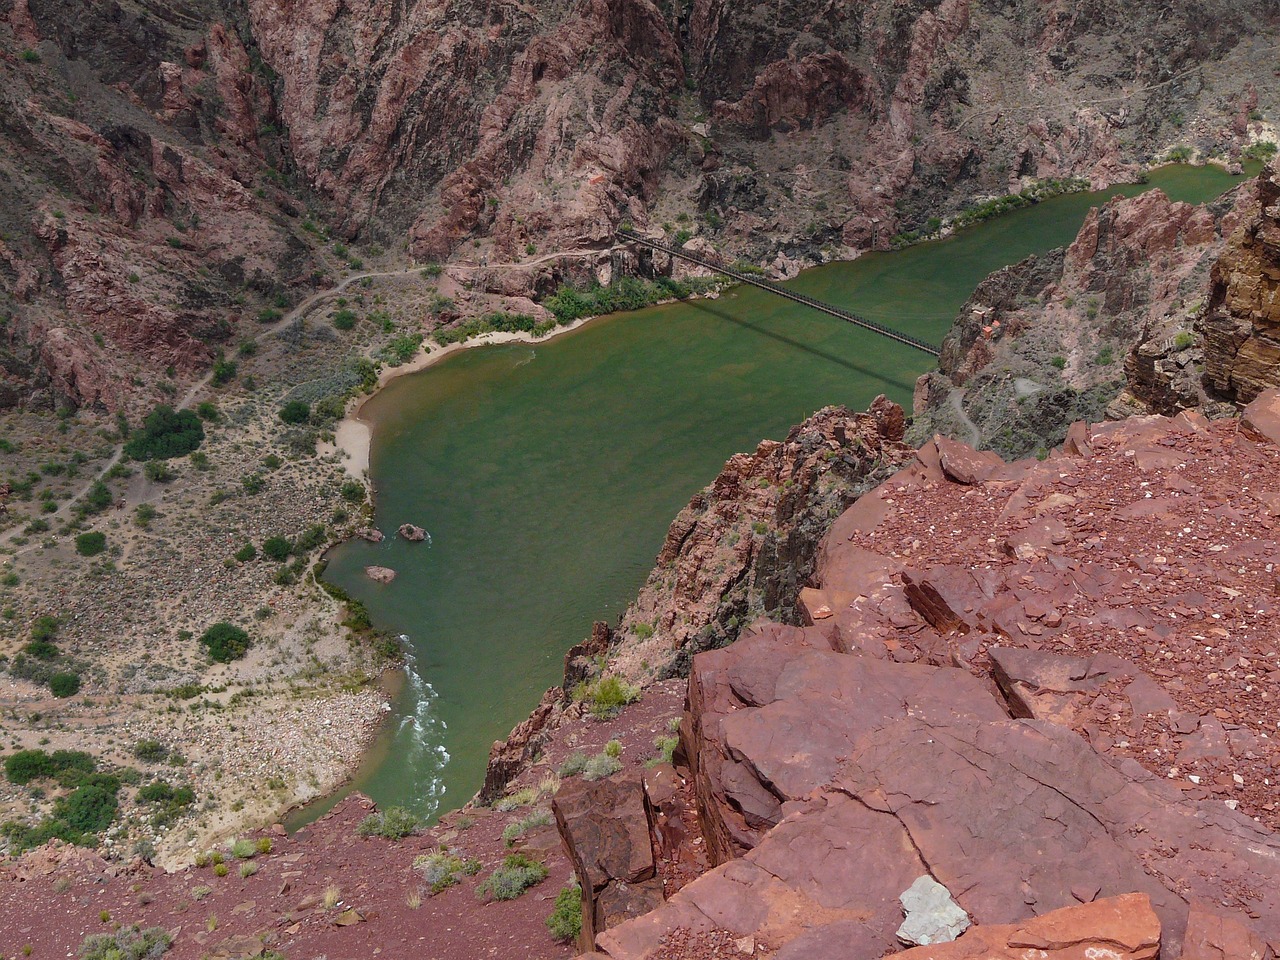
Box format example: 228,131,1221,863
0,0,314,411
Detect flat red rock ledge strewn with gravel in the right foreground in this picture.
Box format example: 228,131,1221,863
566,392,1280,960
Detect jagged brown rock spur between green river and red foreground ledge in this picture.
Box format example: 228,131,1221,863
611,397,911,680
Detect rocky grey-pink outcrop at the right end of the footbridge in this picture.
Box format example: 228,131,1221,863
911,167,1270,457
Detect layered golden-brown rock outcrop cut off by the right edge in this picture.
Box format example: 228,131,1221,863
1201,164,1280,403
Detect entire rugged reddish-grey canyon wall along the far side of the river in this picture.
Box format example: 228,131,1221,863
0,0,1276,407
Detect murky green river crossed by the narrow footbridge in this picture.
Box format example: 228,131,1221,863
309,166,1240,826
